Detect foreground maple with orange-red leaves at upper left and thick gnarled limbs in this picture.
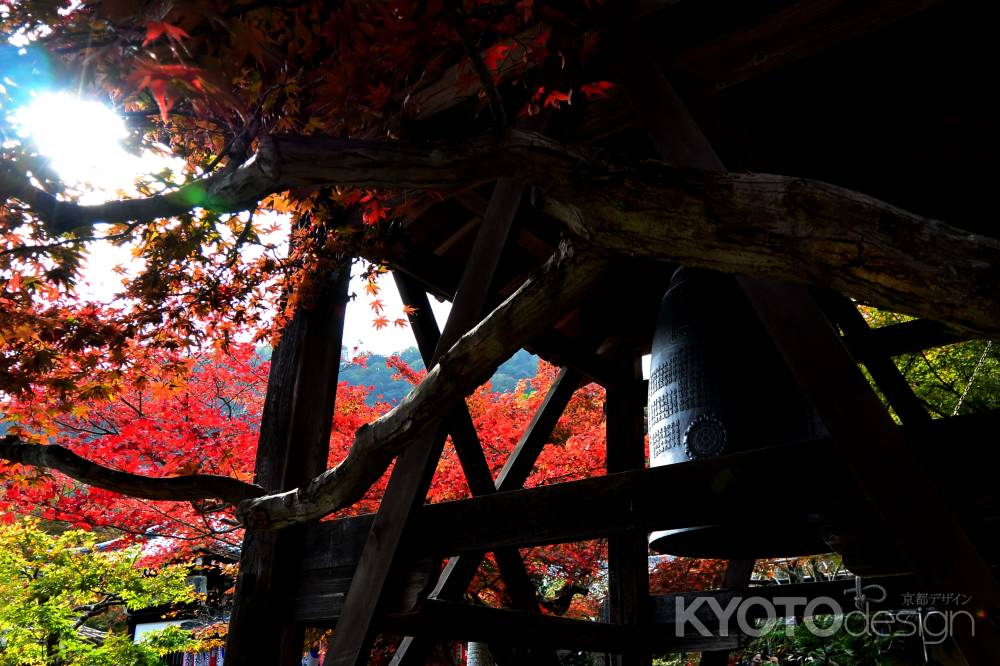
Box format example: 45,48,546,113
0,0,998,526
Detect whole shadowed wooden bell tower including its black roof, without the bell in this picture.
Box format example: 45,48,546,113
226,0,1000,666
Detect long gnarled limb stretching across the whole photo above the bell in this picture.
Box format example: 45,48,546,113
0,130,1000,337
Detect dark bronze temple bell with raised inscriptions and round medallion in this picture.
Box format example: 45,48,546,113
648,268,829,559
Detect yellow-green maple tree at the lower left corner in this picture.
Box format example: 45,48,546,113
0,519,196,666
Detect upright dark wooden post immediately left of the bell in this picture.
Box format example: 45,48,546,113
607,349,651,666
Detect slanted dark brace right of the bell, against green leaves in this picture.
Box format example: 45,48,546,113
820,292,931,424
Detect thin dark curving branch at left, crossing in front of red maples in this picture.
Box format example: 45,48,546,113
0,435,264,504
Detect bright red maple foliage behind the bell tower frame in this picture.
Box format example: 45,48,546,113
2,344,723,640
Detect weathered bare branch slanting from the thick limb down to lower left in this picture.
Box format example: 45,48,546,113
237,242,605,529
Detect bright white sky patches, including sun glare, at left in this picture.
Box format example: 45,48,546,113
11,92,451,354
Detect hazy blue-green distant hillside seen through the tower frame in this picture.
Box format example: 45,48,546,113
340,347,538,403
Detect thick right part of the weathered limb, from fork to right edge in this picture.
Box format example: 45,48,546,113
541,162,1000,338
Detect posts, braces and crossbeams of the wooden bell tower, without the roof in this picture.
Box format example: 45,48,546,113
226,0,1000,666
